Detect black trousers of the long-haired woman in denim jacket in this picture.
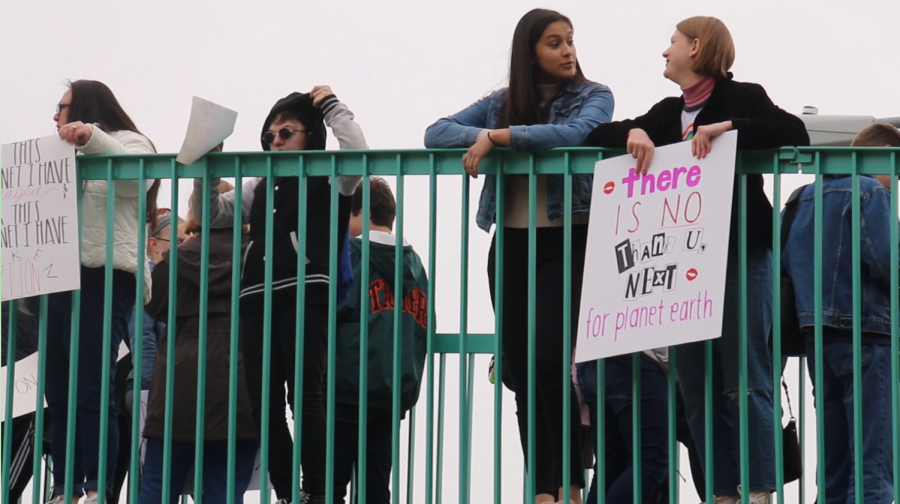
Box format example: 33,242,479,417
488,225,587,495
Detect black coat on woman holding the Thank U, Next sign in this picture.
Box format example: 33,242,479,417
585,73,809,248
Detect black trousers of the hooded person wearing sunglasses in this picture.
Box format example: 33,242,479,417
241,303,328,499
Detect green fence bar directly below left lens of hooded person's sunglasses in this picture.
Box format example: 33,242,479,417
259,155,274,504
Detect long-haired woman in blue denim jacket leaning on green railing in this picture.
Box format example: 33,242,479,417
425,9,613,504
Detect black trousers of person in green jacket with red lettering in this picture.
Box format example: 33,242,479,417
334,404,393,504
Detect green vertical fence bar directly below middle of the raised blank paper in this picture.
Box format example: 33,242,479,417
192,166,214,504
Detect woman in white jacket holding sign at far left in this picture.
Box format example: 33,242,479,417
46,80,159,504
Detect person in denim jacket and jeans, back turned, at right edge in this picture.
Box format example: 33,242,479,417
781,124,900,504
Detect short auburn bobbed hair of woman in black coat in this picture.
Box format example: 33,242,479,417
675,16,734,78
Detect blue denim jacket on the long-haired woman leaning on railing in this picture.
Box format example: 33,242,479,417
425,82,615,231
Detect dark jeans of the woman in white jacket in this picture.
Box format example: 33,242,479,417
46,266,136,497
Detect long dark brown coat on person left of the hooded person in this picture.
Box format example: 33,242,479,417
144,229,256,442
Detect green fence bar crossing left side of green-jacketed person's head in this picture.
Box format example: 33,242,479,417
356,163,370,504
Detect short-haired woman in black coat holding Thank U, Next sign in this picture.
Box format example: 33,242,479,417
587,17,809,503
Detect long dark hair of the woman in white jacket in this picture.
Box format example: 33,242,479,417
69,80,160,229
